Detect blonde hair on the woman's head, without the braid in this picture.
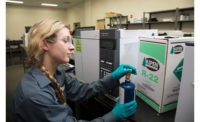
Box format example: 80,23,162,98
27,19,68,66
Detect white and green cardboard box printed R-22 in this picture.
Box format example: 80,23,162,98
136,37,193,113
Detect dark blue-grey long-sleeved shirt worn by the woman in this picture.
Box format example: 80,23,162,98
11,67,119,122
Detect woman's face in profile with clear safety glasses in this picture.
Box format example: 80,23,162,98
48,28,74,64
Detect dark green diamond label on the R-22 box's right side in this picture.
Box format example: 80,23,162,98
173,59,184,82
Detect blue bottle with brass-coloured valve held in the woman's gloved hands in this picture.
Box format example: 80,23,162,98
119,73,135,104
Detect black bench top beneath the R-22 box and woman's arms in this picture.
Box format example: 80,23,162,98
68,90,176,122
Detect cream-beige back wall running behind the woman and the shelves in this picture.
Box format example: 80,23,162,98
6,0,194,39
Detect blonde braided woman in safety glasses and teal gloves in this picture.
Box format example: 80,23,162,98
12,20,137,122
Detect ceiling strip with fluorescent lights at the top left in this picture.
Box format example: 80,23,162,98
6,0,83,8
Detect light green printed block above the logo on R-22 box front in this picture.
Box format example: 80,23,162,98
140,41,166,64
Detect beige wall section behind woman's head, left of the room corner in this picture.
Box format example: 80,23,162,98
6,5,65,40
